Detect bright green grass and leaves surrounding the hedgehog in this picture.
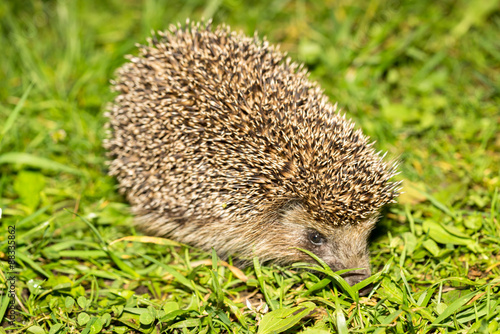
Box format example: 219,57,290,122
0,0,500,334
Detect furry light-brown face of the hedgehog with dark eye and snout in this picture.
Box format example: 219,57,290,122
274,204,376,293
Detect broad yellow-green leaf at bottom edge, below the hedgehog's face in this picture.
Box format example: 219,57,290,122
257,302,316,334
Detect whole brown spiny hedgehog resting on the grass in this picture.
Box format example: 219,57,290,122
105,23,398,292
